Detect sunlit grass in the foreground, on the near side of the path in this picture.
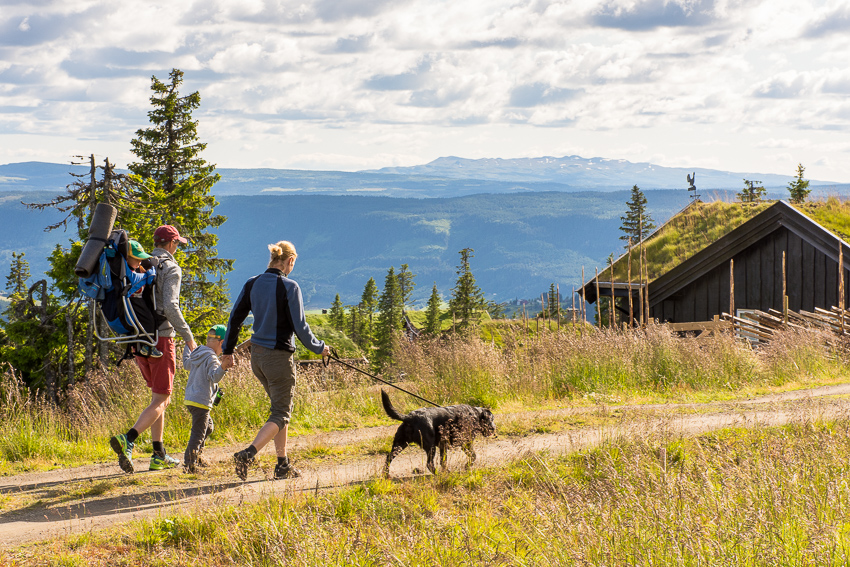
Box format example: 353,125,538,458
9,421,850,567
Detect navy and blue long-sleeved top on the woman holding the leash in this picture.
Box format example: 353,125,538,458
222,268,325,354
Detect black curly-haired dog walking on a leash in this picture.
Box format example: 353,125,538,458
381,390,496,477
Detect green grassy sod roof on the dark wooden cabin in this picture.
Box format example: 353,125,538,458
590,197,850,283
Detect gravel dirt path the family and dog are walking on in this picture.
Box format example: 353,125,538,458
0,384,850,548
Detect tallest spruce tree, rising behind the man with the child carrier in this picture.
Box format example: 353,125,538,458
122,69,233,334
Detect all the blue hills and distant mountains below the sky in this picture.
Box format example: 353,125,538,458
0,156,850,308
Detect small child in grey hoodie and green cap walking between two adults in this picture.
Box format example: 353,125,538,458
183,325,231,474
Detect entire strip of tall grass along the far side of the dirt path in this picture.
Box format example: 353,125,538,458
0,321,848,474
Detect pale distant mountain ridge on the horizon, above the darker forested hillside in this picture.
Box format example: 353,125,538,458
0,156,850,198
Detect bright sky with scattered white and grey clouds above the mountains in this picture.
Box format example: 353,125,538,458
0,0,850,182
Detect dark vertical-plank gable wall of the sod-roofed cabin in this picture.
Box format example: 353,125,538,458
651,228,850,323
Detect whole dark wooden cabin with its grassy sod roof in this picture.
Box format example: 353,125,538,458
582,199,850,323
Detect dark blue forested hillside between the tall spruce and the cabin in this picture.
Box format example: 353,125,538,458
219,191,688,306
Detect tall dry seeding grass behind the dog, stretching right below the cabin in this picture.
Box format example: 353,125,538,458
396,326,847,407
